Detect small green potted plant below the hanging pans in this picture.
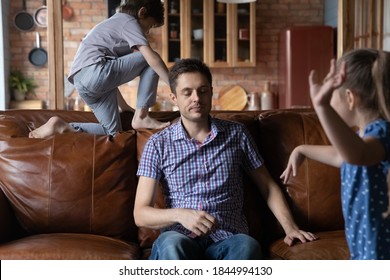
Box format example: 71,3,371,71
9,70,37,101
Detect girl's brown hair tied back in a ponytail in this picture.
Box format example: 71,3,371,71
339,48,390,121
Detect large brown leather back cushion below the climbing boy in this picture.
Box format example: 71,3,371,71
0,131,137,240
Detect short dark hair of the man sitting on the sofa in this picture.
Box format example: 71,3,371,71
169,58,213,95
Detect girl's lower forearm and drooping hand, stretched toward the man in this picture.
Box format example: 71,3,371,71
280,145,342,184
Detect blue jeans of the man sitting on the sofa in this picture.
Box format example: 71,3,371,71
149,231,261,260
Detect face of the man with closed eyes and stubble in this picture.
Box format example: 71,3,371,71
171,72,213,122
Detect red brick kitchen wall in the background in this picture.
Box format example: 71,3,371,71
10,0,324,109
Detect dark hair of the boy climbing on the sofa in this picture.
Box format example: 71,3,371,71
117,0,164,26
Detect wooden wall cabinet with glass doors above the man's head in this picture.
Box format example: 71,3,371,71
162,0,256,67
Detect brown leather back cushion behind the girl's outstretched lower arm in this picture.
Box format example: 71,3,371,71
258,110,344,235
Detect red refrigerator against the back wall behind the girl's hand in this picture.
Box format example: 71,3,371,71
278,26,335,109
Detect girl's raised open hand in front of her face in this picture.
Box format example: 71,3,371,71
309,59,346,107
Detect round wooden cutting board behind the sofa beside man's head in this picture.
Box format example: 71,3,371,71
218,85,248,111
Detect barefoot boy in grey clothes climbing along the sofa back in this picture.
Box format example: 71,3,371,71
30,0,169,138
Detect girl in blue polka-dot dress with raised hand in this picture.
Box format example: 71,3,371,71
281,49,390,260
